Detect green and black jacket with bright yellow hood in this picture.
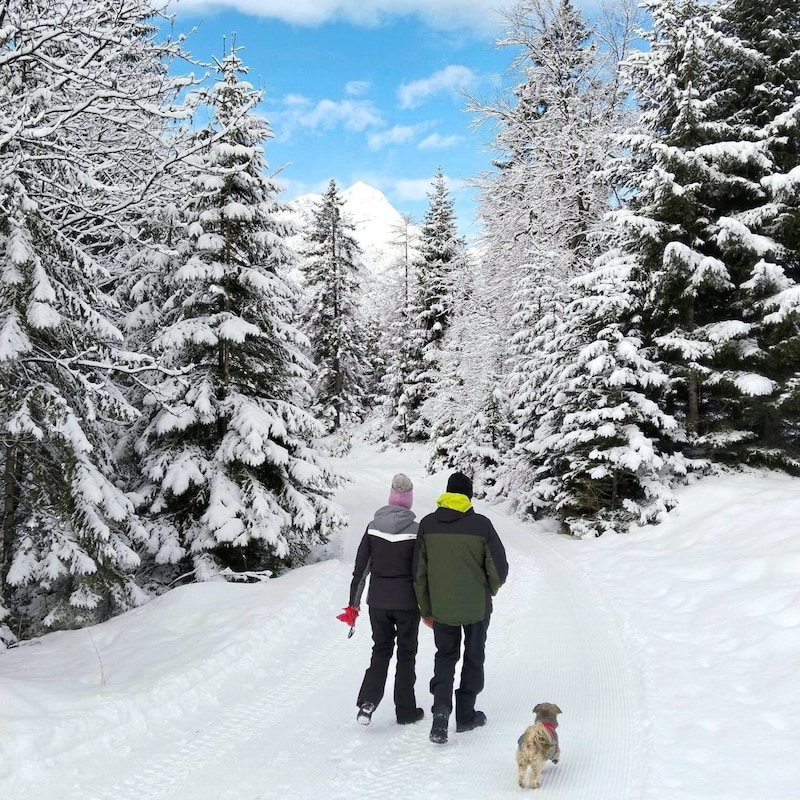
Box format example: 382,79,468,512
413,492,508,625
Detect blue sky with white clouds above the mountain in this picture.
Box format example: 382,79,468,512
170,0,596,237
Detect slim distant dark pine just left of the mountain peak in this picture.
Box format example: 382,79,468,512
302,180,371,432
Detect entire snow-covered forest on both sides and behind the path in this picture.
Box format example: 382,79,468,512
0,0,800,643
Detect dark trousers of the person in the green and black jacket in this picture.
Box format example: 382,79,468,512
431,616,489,724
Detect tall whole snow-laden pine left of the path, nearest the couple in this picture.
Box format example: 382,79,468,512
133,49,344,580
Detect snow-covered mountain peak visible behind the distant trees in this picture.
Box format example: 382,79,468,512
288,181,419,275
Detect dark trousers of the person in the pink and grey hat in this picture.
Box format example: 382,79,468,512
358,606,419,719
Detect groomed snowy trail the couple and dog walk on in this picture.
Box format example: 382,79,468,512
4,452,649,800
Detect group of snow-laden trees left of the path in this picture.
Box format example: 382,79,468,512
0,0,344,642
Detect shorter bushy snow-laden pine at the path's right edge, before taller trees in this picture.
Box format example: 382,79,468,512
516,251,687,536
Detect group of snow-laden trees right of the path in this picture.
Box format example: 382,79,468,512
411,0,800,535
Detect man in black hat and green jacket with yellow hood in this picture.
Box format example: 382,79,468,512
414,472,508,744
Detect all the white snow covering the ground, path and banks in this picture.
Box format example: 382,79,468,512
0,443,800,800
